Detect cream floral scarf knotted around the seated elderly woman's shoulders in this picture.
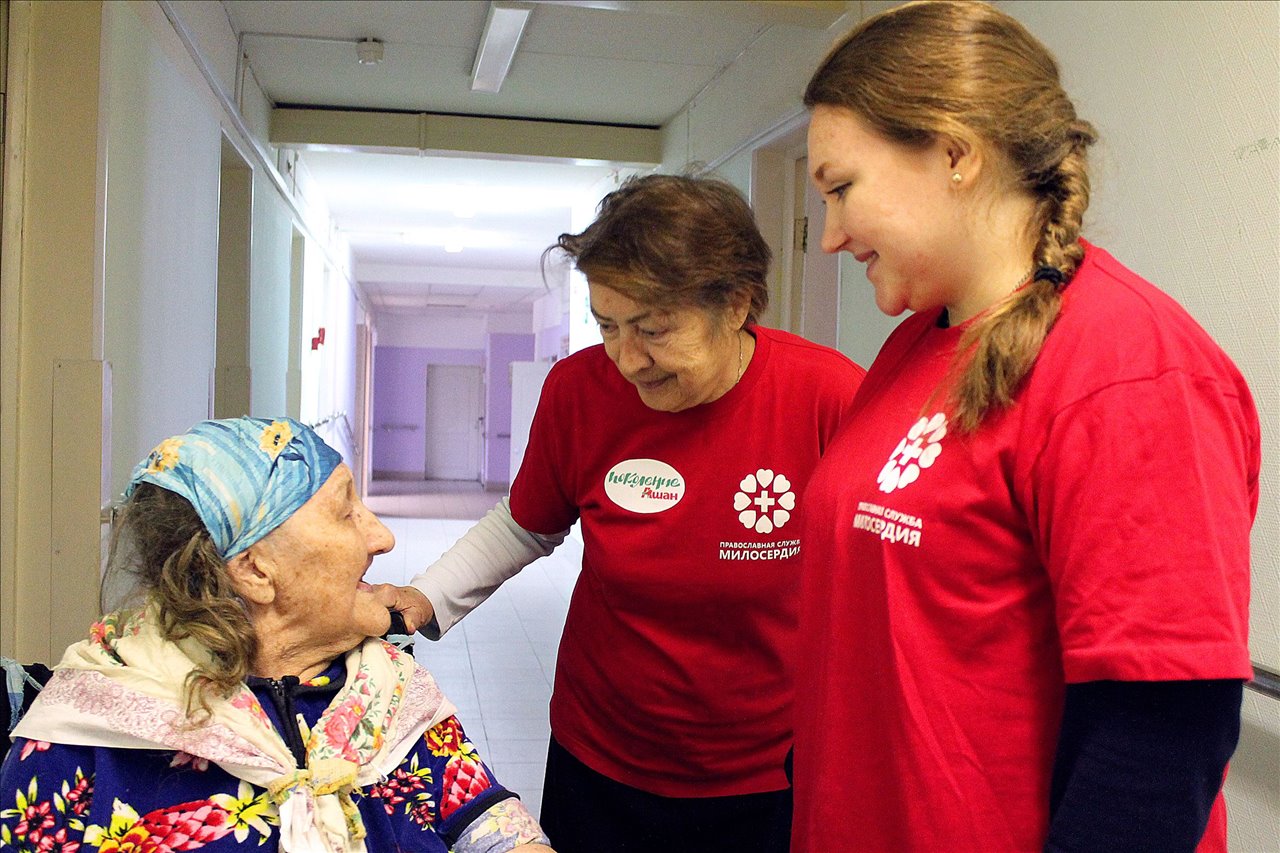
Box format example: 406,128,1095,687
13,608,454,853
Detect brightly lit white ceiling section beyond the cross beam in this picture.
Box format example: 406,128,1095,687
314,151,617,313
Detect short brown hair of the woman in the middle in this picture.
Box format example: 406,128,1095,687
548,174,772,323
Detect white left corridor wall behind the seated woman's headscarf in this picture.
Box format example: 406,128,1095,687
94,3,362,491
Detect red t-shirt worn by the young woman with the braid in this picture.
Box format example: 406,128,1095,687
794,247,1260,853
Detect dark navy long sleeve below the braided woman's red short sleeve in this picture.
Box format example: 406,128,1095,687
1044,680,1244,853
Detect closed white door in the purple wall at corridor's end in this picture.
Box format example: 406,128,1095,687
424,364,484,482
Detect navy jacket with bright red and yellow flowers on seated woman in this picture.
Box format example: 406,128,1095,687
0,658,545,853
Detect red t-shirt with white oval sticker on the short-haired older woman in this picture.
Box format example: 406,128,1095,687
511,327,864,797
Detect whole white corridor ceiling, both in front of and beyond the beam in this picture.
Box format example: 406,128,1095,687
223,0,846,313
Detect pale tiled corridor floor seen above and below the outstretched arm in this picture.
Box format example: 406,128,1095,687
365,493,582,815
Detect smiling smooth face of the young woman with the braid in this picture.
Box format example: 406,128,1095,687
809,106,972,316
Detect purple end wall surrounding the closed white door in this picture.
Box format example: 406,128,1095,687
372,345,486,476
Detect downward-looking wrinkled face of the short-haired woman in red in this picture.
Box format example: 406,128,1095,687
588,282,746,411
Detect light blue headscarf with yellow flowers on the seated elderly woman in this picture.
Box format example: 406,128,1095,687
124,418,342,560
